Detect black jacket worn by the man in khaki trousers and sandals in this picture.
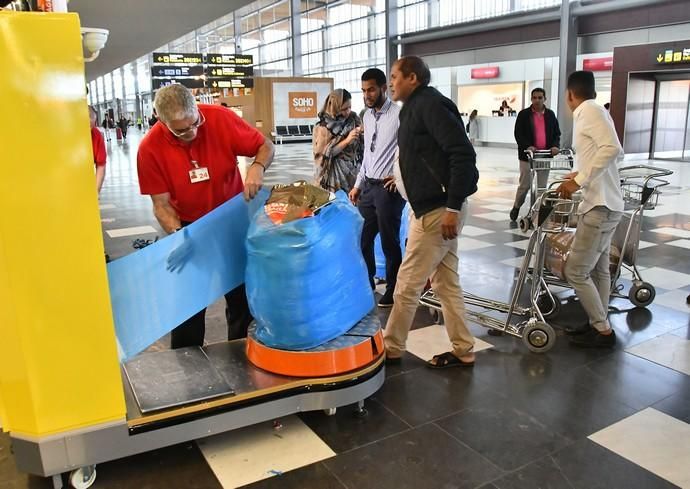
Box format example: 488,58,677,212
398,87,479,217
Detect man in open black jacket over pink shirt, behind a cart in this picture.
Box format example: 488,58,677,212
510,88,561,221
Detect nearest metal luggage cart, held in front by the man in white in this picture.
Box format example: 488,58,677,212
419,190,574,353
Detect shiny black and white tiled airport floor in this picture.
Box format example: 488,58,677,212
0,131,690,489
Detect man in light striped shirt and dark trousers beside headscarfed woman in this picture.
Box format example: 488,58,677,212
349,68,405,307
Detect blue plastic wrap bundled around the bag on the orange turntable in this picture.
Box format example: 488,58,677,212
245,191,374,350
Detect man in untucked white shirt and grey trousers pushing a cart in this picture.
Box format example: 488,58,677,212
558,71,623,348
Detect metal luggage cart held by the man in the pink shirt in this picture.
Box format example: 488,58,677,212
518,148,574,233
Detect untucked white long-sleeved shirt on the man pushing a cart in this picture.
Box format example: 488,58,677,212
573,100,623,214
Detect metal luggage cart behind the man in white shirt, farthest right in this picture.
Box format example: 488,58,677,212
540,165,673,308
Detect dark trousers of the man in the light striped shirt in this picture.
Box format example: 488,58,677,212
358,180,405,294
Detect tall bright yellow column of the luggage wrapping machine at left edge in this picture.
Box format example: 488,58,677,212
0,11,125,436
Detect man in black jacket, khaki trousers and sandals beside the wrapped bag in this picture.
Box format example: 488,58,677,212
385,56,479,368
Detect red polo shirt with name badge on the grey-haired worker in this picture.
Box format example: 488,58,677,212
137,104,264,222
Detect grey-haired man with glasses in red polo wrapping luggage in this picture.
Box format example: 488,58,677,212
137,84,273,348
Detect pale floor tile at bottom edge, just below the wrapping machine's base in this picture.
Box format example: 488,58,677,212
197,416,335,489
